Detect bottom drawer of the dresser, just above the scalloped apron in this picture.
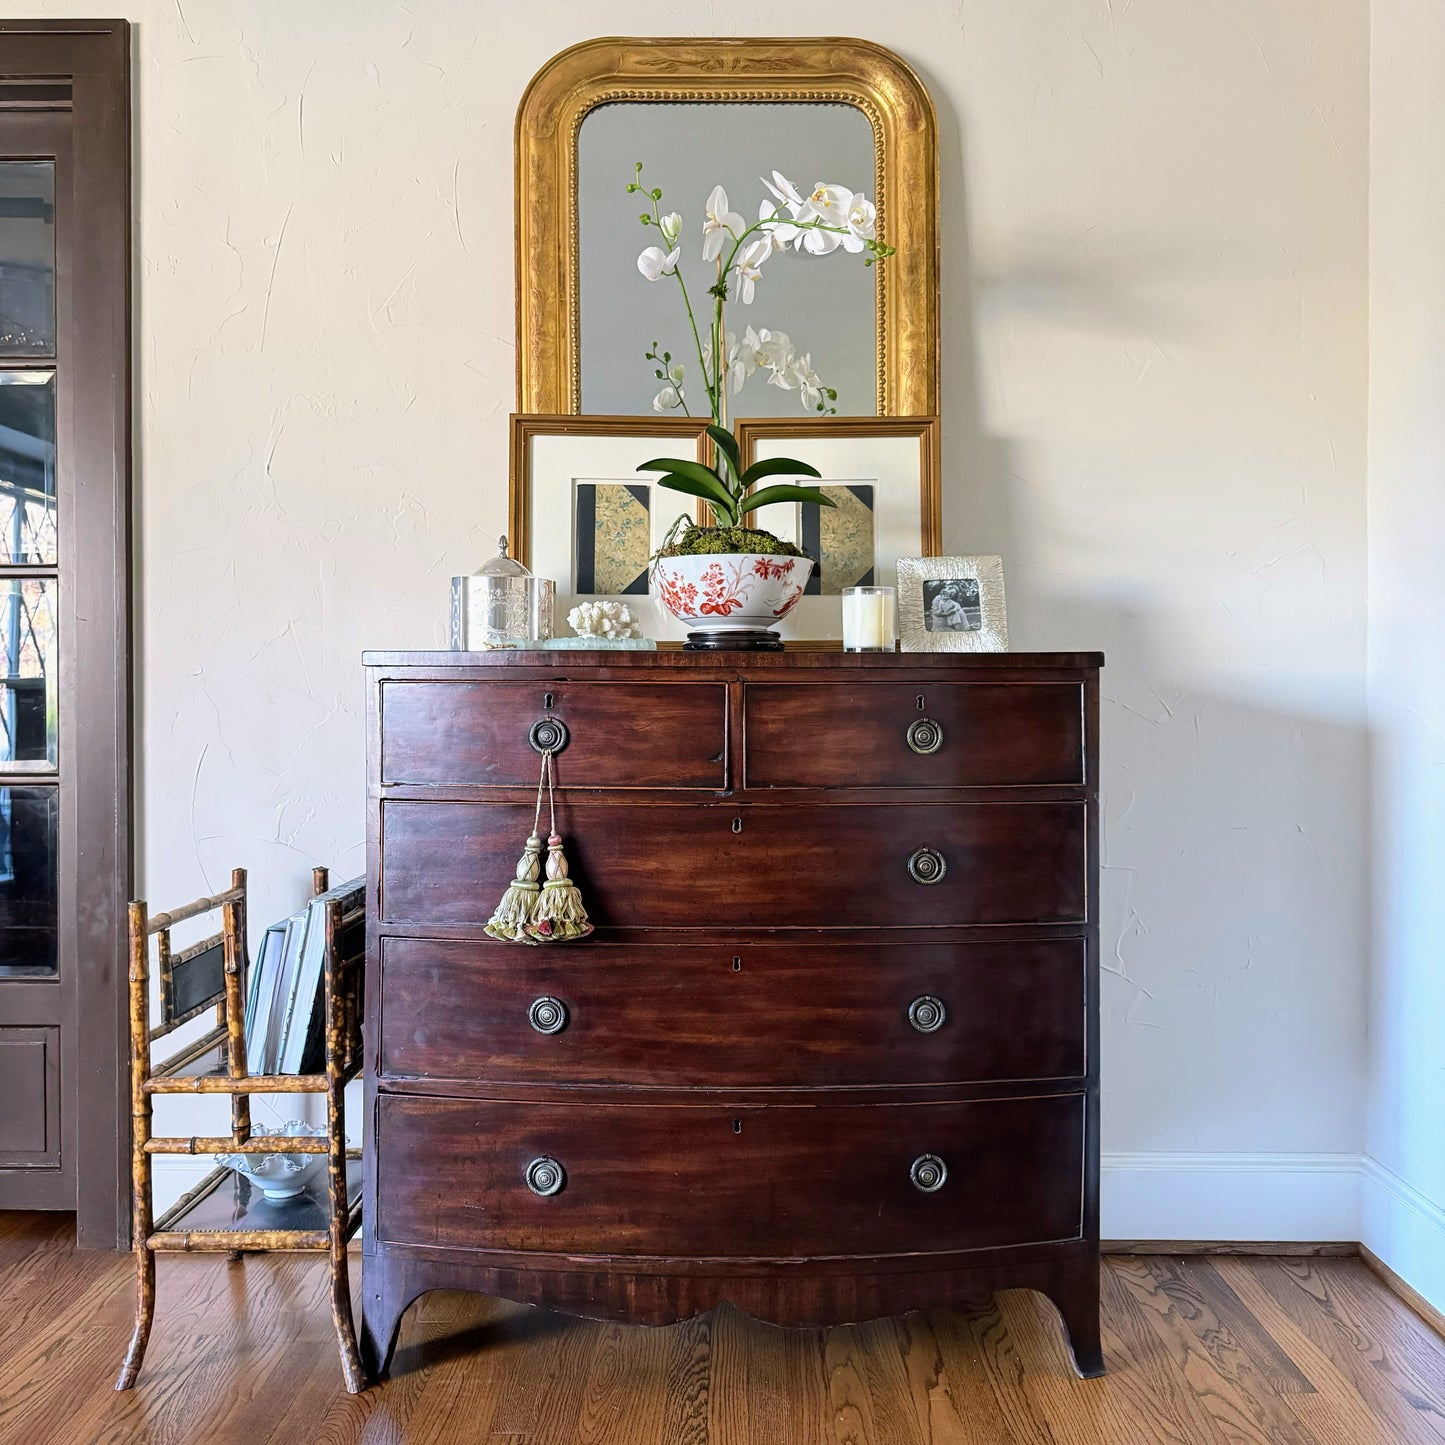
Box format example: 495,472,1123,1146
376,1094,1084,1257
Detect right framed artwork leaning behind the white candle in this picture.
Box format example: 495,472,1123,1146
734,416,942,646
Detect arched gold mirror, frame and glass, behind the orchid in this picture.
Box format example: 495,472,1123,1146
516,39,938,416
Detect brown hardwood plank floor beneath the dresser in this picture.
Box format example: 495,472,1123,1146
0,1214,1445,1445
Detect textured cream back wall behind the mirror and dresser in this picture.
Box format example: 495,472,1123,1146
0,0,1368,1235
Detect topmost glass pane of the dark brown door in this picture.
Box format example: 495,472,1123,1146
0,160,55,355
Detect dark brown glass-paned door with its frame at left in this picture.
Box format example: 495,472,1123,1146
0,19,131,1248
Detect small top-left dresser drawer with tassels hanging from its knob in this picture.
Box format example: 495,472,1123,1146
380,681,727,791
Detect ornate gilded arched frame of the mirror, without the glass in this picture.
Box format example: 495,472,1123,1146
516,38,939,416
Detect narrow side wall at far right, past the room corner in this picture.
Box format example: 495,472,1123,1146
1363,0,1445,1309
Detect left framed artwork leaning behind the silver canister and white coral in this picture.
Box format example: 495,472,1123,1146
507,413,712,640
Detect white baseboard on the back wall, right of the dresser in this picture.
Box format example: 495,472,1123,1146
1100,1152,1364,1257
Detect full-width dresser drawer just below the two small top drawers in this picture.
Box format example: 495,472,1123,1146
380,799,1085,924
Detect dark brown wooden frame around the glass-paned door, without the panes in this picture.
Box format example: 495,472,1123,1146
0,19,131,1248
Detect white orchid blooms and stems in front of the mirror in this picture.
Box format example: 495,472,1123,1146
627,160,893,428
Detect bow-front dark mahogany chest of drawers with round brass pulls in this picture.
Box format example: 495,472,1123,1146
363,652,1103,1374
